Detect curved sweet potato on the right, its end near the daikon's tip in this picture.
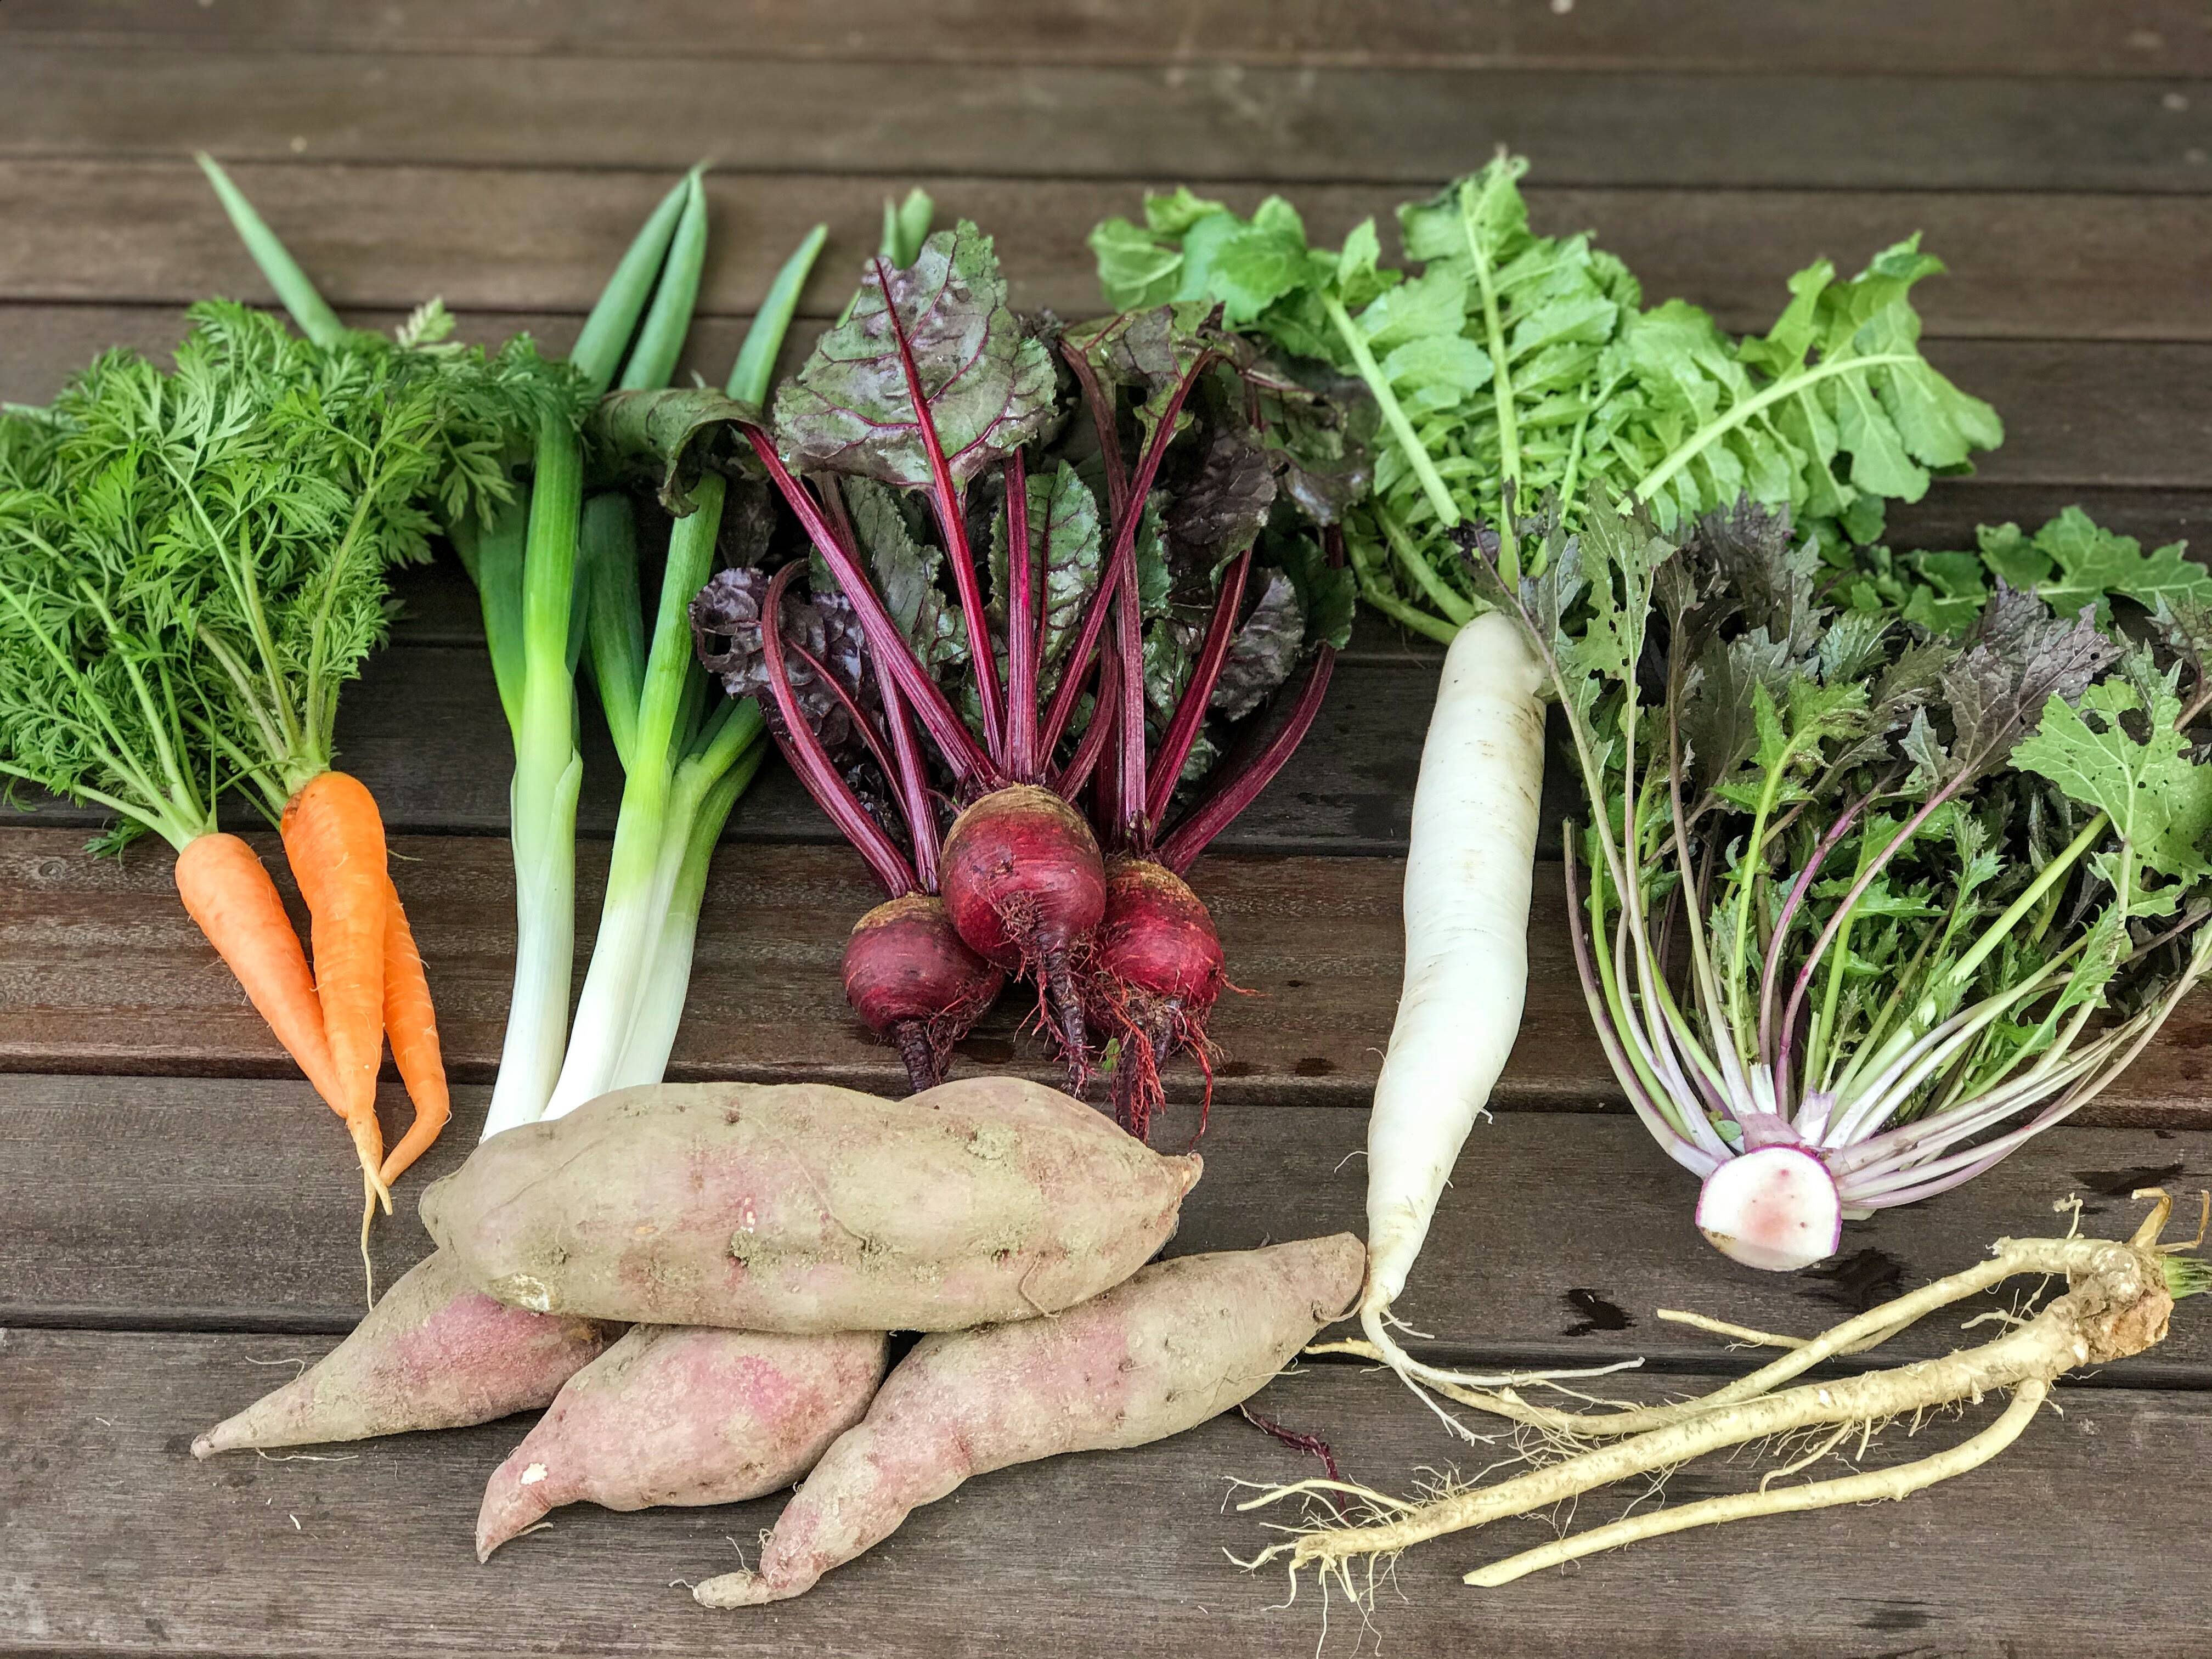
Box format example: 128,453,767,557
695,1232,1367,1608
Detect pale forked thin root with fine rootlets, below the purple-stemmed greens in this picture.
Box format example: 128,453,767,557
1239,1188,2212,1599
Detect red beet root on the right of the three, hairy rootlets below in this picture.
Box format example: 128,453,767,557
1088,858,1228,1139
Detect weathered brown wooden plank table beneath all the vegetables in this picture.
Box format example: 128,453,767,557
0,0,2212,1655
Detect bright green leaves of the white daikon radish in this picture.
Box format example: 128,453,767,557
1091,155,2004,639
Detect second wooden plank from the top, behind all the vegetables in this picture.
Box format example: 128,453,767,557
0,44,2212,195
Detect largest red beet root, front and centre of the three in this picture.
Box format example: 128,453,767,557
938,783,1106,1064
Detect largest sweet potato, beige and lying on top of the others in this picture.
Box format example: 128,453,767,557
422,1077,1201,1334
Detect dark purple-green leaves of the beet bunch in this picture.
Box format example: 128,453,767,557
701,221,1367,845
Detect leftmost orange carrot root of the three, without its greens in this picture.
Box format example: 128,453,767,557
177,834,343,1115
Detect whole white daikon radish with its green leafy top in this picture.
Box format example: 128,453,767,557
1091,155,2002,1383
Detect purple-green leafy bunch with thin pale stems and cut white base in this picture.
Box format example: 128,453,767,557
1469,491,2212,1269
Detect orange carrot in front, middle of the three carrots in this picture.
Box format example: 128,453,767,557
281,772,392,1210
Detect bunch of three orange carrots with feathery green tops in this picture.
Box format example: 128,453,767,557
0,303,577,1210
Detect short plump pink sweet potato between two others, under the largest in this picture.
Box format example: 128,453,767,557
476,1314,889,1562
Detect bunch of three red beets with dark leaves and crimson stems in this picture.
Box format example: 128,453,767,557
695,223,1365,1132
